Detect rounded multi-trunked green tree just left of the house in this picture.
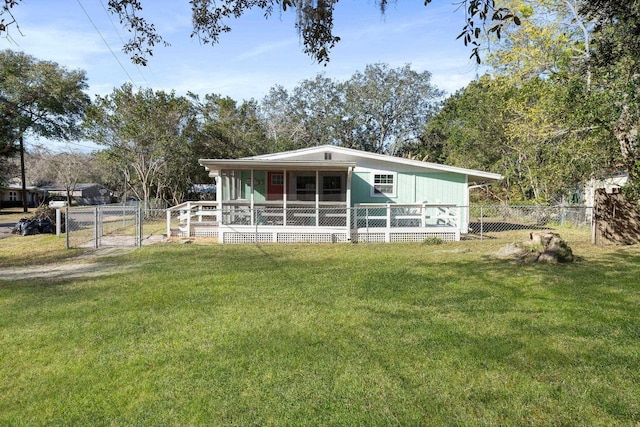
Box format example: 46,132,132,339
86,84,195,207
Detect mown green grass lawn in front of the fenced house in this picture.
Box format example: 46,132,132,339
0,236,640,426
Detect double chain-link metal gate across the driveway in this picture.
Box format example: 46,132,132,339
65,205,142,249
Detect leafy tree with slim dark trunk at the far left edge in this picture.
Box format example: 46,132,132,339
0,50,90,212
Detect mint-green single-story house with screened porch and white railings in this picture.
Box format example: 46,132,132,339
167,145,502,243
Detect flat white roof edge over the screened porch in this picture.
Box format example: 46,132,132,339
198,158,356,177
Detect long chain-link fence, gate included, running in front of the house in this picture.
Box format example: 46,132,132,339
65,204,593,248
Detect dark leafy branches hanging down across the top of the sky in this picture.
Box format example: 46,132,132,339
0,0,520,65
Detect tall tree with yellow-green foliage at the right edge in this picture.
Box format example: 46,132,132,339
482,0,640,199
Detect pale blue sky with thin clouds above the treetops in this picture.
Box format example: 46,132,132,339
0,0,480,101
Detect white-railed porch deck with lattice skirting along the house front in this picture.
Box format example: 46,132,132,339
167,201,460,243
